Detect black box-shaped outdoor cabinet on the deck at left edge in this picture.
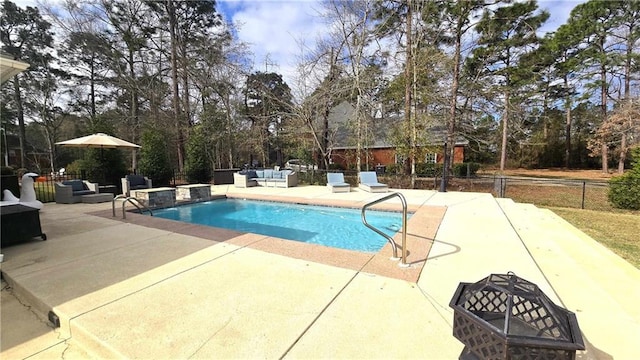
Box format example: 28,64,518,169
0,205,47,247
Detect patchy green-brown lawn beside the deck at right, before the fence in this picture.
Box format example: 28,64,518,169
549,207,640,269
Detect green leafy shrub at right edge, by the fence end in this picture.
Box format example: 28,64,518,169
608,147,640,210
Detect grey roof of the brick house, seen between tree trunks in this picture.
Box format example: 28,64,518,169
329,101,469,150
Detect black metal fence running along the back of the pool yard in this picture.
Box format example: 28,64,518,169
18,169,614,211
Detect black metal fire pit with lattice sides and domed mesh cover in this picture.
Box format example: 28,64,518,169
449,273,584,360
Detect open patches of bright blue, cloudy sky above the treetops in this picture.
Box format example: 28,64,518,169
14,0,585,87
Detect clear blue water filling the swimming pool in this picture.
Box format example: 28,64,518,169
153,199,410,252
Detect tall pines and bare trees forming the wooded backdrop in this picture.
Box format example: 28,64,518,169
0,0,640,179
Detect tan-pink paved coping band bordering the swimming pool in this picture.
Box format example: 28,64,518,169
90,193,446,283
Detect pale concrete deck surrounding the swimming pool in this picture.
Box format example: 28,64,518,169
0,186,640,359
